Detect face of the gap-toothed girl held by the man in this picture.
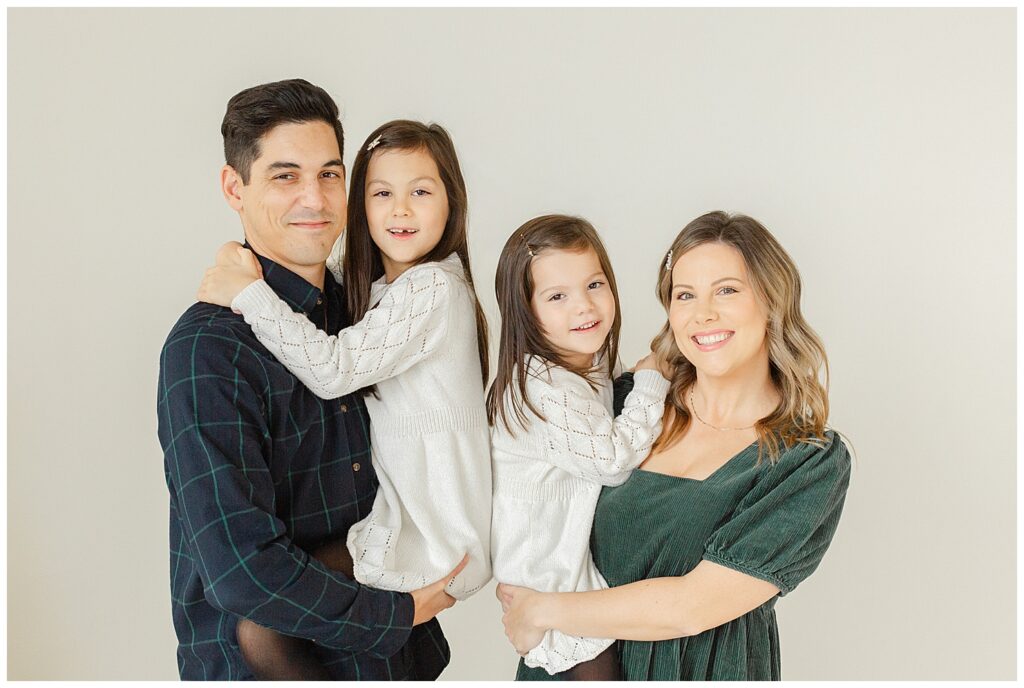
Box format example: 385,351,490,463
366,149,449,282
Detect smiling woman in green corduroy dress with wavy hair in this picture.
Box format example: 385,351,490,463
498,212,850,680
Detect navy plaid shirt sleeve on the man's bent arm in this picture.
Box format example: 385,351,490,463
158,331,414,657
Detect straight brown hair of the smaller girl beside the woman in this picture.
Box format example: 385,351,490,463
487,215,622,434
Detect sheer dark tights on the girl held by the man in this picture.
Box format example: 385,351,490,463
236,540,352,681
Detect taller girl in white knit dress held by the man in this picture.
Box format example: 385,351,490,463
200,120,492,679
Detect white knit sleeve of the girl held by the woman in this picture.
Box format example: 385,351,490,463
529,371,669,485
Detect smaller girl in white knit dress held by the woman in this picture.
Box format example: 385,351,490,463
487,215,669,680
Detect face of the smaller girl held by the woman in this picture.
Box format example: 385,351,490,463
529,248,615,368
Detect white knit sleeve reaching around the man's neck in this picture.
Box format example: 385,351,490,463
231,265,451,399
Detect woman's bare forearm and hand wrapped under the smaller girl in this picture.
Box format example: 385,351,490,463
498,561,779,654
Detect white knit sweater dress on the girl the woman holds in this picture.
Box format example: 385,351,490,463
490,357,669,674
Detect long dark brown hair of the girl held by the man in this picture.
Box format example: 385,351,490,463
342,120,488,386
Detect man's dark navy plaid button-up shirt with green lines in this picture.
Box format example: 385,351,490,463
157,257,450,680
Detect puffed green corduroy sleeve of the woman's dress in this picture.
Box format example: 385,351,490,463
703,432,850,595
